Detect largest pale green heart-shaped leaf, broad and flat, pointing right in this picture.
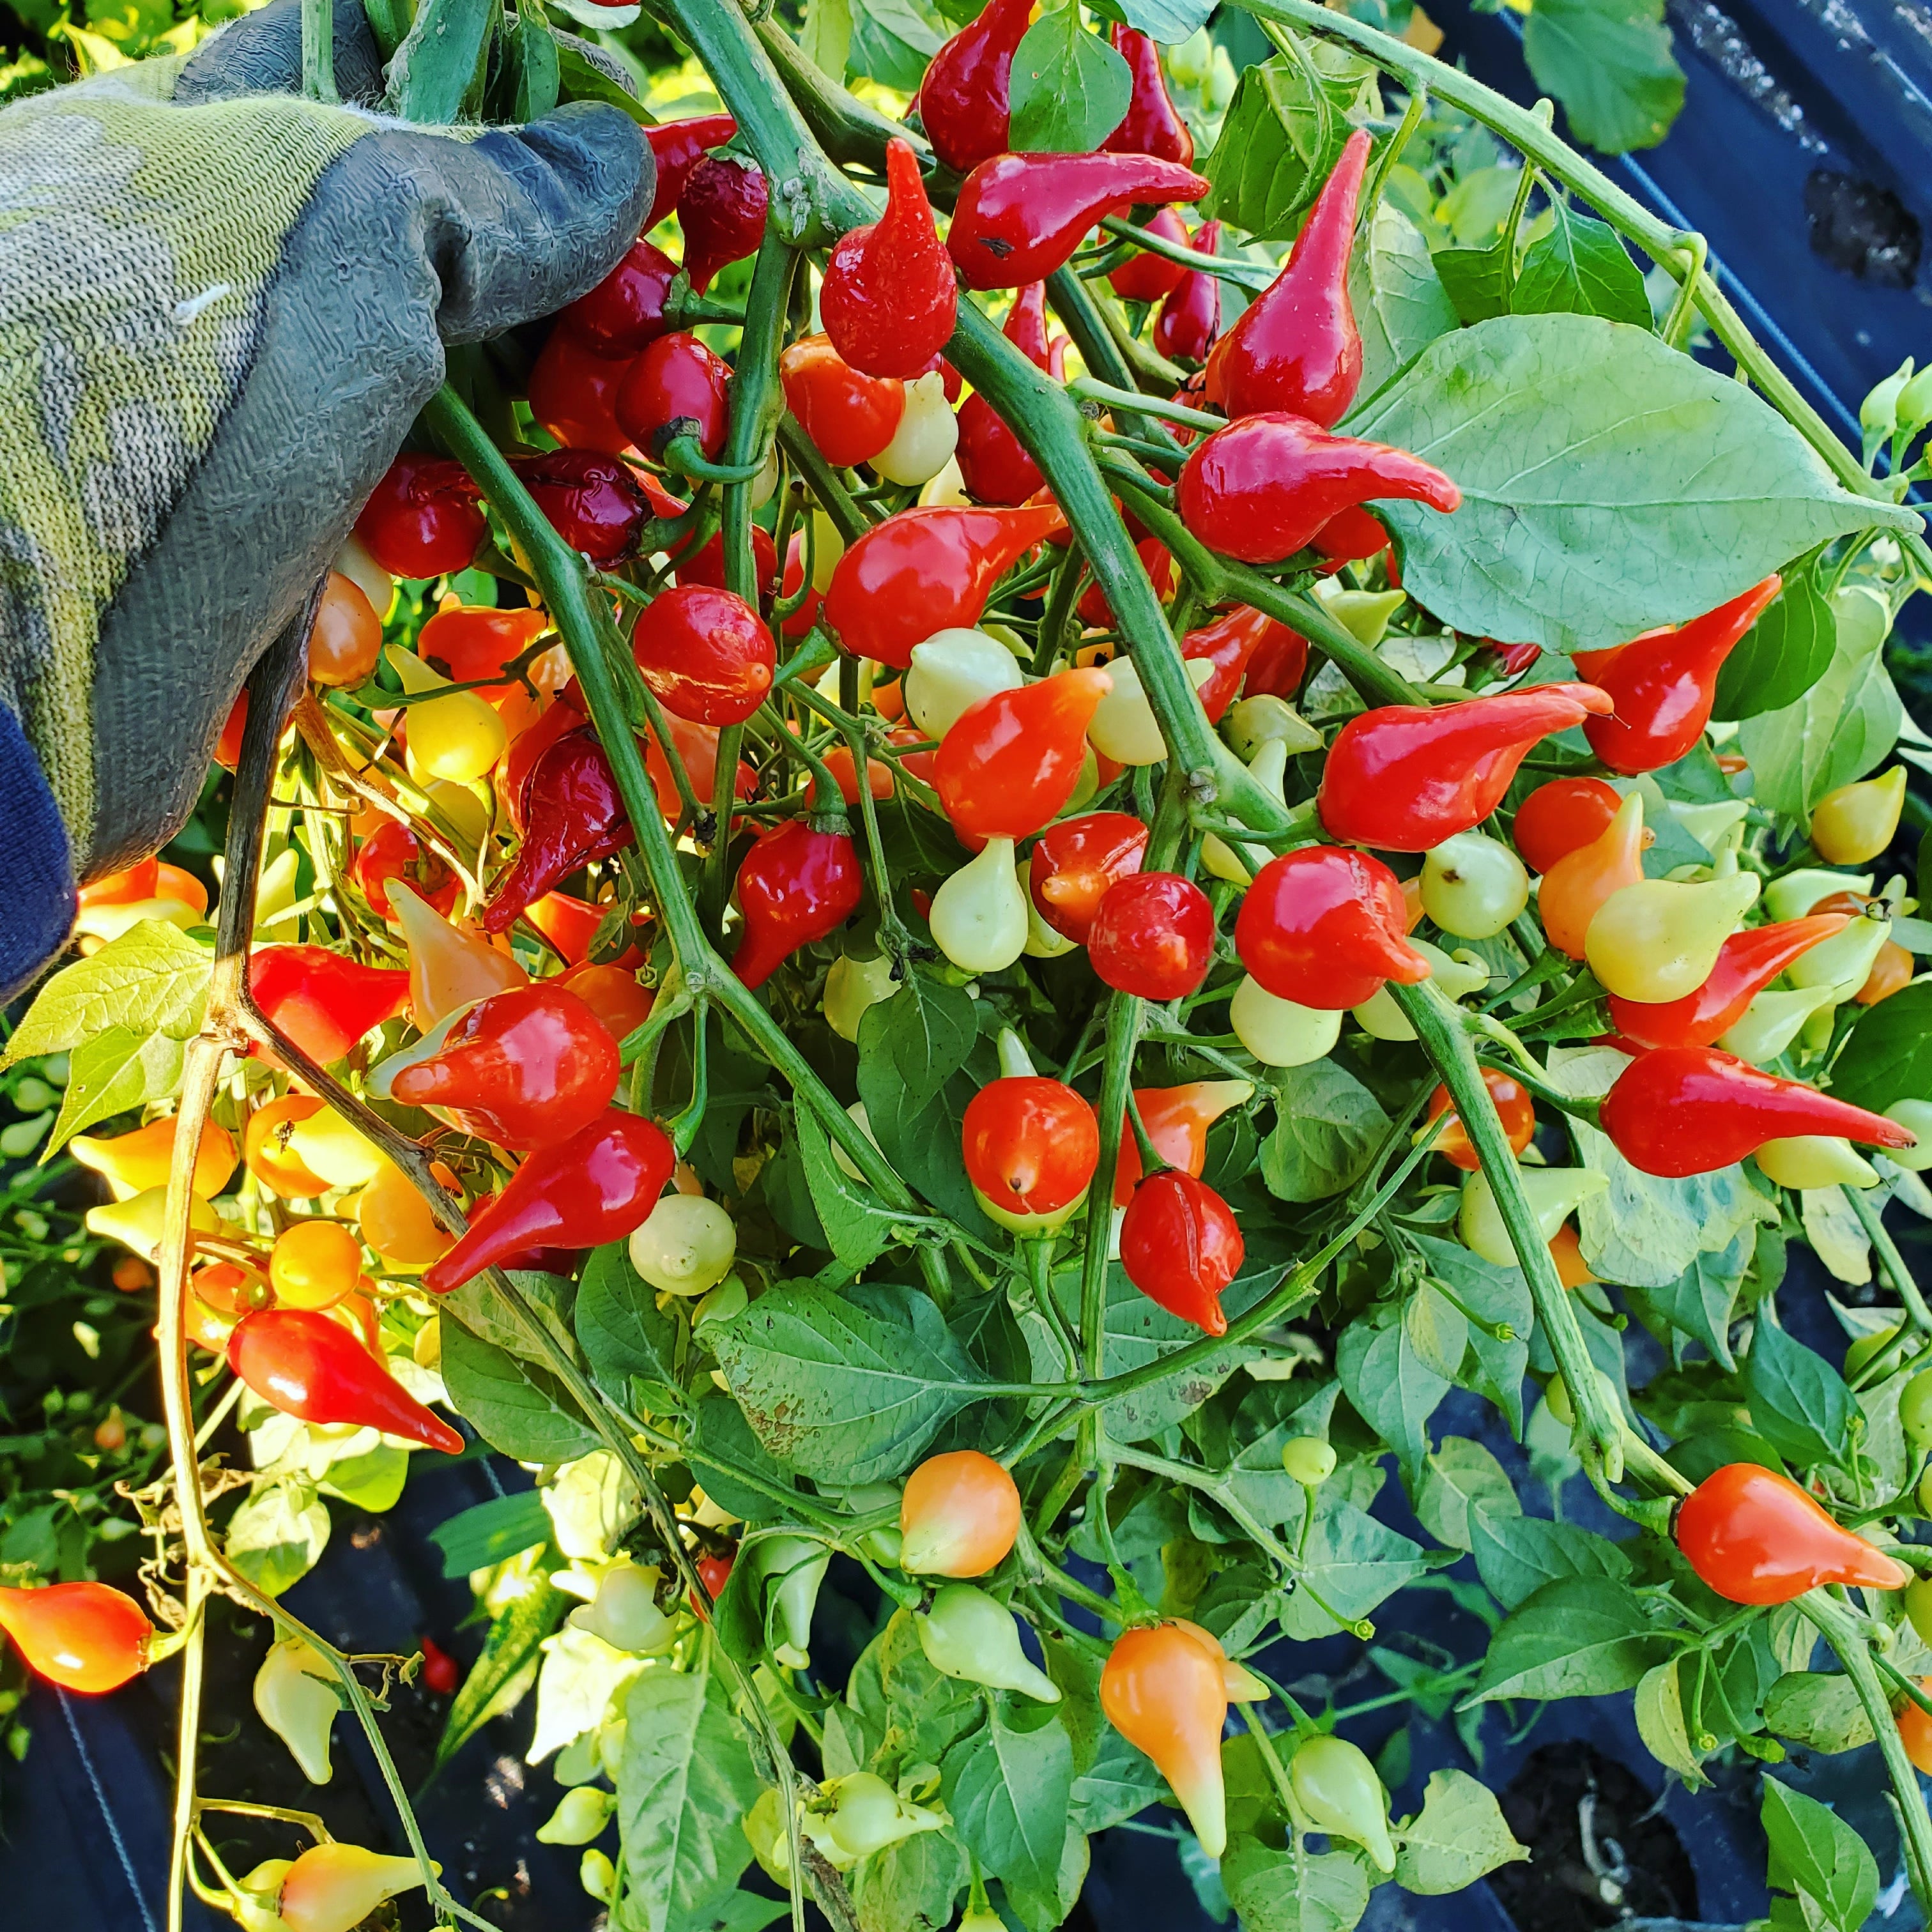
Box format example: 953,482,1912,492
1345,315,1917,651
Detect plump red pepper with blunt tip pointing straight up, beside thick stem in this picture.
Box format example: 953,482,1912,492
819,141,958,377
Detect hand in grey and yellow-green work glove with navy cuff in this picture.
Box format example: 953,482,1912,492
0,0,655,997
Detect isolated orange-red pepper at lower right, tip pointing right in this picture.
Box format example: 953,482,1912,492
1671,1462,1913,1604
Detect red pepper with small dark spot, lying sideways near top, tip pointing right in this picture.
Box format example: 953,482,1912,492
947,155,1209,288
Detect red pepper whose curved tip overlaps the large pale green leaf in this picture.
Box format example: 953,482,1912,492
1175,408,1462,564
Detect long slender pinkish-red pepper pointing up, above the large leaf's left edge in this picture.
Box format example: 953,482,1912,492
1208,128,1376,427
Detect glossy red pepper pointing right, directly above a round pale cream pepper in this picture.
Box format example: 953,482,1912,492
1317,684,1609,852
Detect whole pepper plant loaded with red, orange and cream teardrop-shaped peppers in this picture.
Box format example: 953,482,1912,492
11,0,1932,1932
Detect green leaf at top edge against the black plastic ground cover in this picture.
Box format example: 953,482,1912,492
1522,0,1685,155
